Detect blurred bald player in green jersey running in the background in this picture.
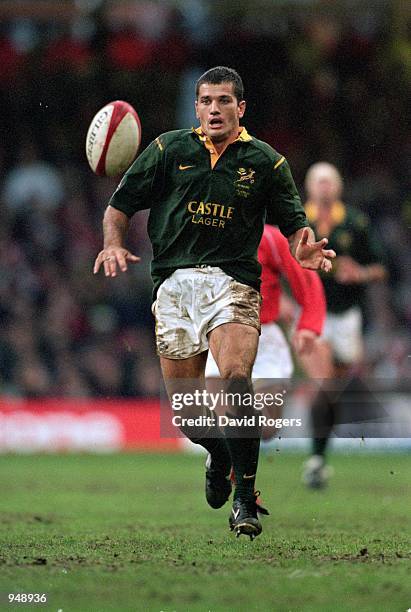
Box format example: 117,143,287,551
301,162,386,488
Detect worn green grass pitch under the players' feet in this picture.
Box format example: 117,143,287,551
0,452,411,612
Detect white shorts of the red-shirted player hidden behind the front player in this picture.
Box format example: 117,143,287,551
205,323,294,379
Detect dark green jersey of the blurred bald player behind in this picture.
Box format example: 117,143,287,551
305,201,383,313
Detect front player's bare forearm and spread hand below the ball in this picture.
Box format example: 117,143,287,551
93,205,140,276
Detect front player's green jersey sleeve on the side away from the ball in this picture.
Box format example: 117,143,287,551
267,159,309,237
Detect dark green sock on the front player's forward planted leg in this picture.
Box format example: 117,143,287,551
225,378,261,499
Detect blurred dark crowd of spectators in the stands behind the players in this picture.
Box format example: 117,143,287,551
0,0,411,397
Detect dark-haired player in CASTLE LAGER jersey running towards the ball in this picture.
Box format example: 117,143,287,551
94,66,335,538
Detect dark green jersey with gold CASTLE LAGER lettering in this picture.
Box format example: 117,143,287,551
109,128,308,295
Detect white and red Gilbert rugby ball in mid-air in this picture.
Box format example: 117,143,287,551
86,100,141,176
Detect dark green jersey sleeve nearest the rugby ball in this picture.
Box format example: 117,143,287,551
109,138,163,217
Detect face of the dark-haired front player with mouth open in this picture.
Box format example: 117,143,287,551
195,83,245,143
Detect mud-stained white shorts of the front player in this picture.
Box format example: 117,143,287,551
152,266,261,359
